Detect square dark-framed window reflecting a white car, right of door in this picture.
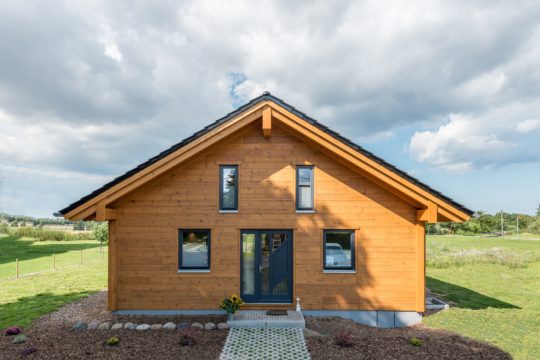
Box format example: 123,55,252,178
324,230,355,270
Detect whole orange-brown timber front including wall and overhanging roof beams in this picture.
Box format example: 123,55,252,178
61,94,468,312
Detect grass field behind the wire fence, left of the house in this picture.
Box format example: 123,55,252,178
0,235,107,280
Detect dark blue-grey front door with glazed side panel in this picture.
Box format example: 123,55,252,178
240,230,293,303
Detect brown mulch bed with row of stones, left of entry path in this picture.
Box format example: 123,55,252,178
0,292,228,360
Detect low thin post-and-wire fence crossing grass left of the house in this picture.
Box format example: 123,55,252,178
0,247,108,280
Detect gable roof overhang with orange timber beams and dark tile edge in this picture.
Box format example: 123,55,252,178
60,95,472,223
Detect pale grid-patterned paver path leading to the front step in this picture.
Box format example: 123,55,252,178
220,328,310,360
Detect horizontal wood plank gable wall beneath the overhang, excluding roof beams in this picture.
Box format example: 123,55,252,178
111,123,423,310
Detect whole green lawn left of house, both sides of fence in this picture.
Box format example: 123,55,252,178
0,236,107,328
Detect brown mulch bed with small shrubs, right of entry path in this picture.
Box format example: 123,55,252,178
306,316,512,360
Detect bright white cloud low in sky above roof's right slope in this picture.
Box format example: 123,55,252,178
409,101,540,171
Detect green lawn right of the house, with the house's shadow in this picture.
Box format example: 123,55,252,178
424,236,540,359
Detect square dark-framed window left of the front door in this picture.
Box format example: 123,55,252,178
178,230,210,270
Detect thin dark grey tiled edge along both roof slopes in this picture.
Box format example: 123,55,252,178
58,91,474,216
